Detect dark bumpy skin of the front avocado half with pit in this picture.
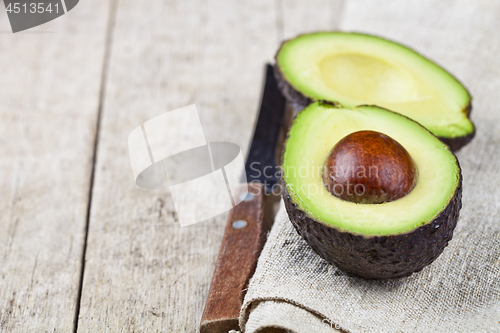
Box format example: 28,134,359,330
282,174,462,279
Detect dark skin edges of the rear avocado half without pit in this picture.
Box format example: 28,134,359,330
274,65,476,152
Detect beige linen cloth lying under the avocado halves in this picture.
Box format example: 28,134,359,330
240,0,500,333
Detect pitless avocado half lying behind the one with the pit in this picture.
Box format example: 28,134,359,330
275,32,475,151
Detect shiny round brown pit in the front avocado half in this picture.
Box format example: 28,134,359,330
323,131,417,204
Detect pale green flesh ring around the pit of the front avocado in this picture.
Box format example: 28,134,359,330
282,102,460,236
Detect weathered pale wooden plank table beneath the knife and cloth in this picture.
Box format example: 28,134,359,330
0,0,342,332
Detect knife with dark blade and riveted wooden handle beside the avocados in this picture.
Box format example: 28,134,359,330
200,64,292,333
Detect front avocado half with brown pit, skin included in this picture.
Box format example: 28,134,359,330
282,102,462,279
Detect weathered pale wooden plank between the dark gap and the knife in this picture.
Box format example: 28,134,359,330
78,0,277,332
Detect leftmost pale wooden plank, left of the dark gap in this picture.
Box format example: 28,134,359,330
0,0,108,332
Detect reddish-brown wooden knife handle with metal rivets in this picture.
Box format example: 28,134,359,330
200,183,275,333
